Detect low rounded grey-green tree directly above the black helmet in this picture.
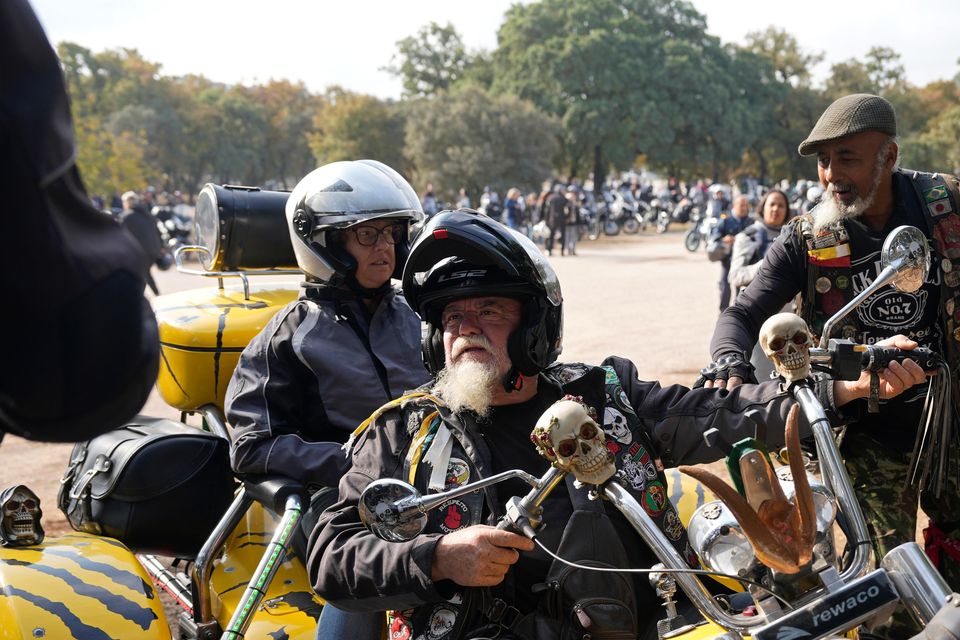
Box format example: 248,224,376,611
406,86,559,200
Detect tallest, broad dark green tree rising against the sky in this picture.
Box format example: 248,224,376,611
493,0,776,185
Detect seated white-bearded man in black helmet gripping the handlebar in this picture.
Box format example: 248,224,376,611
308,211,923,639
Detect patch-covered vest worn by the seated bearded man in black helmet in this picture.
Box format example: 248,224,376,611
388,364,697,640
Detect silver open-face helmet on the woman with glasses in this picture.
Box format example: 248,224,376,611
286,160,423,293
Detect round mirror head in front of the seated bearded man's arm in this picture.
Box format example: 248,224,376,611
357,478,427,542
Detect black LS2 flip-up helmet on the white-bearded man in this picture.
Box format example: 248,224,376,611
403,209,563,390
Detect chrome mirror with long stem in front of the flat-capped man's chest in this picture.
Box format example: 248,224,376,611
820,225,930,349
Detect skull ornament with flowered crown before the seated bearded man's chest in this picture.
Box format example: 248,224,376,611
530,396,617,485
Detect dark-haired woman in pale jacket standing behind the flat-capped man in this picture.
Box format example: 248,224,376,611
728,189,793,381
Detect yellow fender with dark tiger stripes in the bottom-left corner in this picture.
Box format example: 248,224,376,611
0,533,170,640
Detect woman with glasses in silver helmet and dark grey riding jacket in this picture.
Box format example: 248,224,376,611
226,160,429,637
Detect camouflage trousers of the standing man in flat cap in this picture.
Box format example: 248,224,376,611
841,427,960,638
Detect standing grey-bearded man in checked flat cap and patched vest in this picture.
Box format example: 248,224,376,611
705,94,960,636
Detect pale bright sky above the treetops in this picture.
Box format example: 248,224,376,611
28,0,960,98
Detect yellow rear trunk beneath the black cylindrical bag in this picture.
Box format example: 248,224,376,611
153,282,300,411
